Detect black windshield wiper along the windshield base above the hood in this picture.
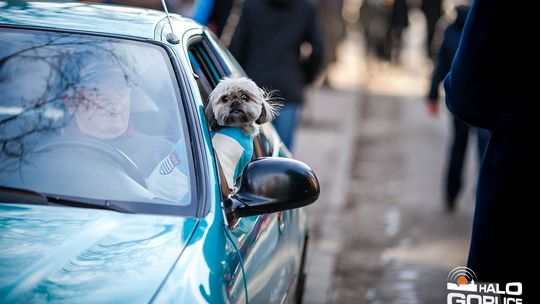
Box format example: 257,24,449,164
0,186,133,213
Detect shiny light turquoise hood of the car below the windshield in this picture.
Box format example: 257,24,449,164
0,204,197,303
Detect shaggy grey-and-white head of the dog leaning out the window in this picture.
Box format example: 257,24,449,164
205,77,275,136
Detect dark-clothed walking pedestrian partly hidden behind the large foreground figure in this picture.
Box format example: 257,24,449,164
426,5,489,211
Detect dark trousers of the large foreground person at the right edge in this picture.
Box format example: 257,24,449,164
467,130,540,303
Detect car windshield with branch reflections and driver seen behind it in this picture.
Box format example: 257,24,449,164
0,29,193,214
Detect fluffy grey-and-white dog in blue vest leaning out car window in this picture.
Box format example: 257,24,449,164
205,77,276,189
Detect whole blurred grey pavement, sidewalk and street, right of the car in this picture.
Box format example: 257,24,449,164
293,17,478,304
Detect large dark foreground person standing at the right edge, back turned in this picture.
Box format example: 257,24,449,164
444,0,540,303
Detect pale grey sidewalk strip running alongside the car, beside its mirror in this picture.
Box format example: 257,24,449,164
294,89,360,303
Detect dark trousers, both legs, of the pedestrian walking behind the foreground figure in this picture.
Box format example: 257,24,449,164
445,117,489,206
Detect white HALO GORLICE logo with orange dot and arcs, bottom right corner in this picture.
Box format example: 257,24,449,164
446,267,523,304
